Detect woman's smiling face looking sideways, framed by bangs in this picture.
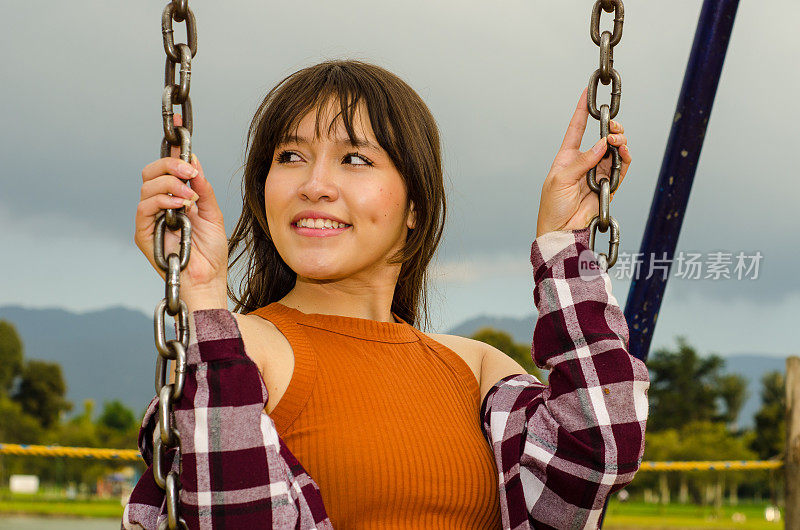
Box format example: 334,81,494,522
264,100,414,280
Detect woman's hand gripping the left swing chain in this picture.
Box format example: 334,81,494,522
134,114,228,310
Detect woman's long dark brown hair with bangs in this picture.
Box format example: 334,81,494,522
228,60,446,328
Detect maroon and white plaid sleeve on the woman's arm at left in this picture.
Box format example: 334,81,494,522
122,309,333,529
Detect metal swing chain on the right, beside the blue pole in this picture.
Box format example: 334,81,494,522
586,0,625,271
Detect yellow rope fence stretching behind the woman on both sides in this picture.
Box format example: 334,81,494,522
0,443,783,471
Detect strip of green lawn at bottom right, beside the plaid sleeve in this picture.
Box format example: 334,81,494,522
603,499,783,530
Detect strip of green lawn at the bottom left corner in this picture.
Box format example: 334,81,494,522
0,490,122,519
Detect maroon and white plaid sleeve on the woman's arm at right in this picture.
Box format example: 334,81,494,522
481,228,650,530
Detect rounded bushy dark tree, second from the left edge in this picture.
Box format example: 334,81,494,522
14,360,72,429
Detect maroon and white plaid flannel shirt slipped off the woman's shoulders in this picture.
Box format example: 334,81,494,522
122,228,649,530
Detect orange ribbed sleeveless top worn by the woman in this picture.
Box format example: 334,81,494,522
251,302,501,530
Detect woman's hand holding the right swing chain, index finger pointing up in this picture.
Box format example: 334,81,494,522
536,89,631,237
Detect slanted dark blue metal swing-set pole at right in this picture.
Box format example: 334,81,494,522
598,0,739,528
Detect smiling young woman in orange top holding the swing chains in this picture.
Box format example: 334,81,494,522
123,61,648,529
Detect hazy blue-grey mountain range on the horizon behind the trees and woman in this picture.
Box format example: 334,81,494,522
0,305,786,426
